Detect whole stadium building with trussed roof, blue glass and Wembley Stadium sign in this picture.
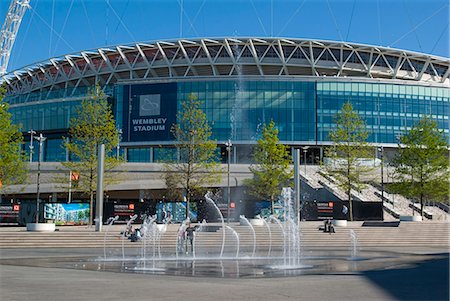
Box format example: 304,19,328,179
3,38,450,220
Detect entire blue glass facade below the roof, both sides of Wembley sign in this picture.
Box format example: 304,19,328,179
7,78,450,162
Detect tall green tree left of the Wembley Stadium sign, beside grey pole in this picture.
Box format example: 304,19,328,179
62,86,121,225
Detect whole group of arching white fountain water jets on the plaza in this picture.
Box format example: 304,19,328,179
103,188,302,262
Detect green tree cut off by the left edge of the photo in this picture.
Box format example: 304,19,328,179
0,86,27,192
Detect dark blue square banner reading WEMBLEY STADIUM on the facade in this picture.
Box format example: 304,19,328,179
122,83,177,142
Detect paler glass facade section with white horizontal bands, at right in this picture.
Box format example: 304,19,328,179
317,82,450,143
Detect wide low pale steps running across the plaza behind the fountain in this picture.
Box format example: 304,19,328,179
0,221,450,253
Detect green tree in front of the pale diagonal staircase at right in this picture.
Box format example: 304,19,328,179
323,102,374,221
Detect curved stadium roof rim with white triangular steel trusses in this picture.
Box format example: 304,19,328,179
3,38,450,95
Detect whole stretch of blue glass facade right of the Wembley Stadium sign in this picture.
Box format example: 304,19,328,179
174,81,450,144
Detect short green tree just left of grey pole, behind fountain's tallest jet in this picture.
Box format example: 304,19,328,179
245,121,294,214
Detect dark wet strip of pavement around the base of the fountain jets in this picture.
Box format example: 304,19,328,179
0,251,442,278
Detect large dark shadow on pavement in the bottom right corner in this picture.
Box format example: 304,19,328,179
362,253,449,301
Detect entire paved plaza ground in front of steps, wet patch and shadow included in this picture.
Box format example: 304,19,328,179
0,248,449,301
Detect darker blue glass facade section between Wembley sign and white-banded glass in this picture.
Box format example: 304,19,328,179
178,81,316,143
